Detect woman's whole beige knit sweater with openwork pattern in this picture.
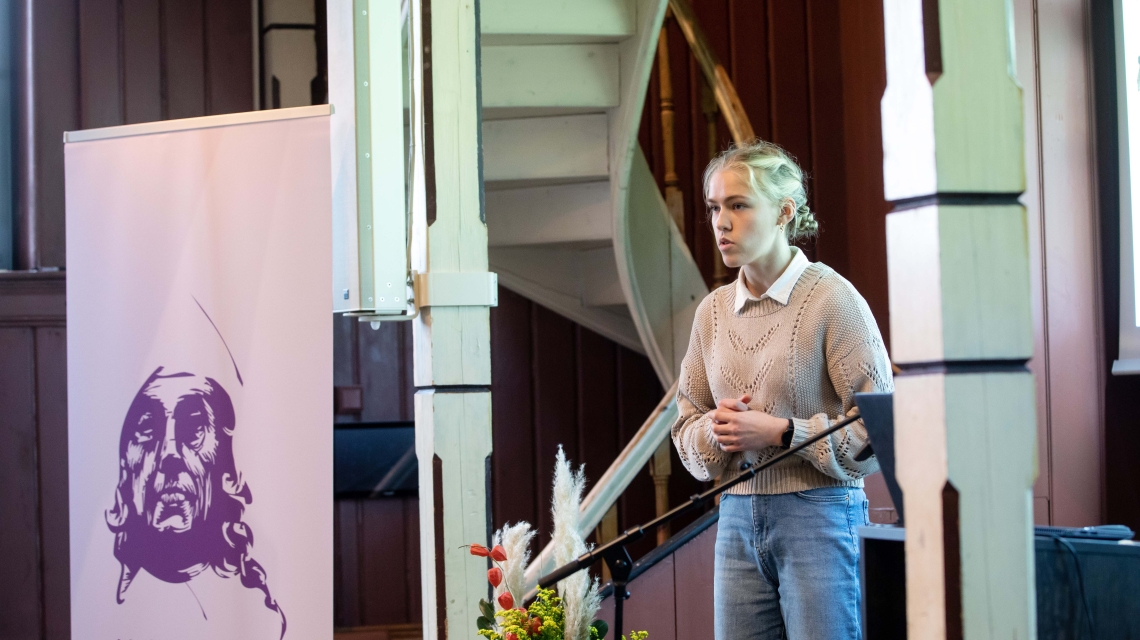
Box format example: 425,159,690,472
673,262,894,495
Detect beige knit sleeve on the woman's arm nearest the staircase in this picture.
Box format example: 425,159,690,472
671,297,732,481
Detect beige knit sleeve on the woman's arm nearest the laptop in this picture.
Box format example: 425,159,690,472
791,284,895,481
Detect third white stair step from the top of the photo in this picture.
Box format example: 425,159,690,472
483,114,610,188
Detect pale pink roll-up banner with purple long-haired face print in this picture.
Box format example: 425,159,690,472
65,106,333,640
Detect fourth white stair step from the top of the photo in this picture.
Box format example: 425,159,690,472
486,181,613,249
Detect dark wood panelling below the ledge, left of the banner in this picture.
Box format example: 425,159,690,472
0,273,71,640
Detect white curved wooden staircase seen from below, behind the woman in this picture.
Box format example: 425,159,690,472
480,0,708,388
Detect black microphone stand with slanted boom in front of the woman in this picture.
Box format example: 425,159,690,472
538,413,860,639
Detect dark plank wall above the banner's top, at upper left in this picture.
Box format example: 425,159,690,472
14,0,253,268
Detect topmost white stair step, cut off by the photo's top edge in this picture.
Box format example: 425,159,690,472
479,0,637,44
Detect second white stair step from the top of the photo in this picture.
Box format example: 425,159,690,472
482,44,620,111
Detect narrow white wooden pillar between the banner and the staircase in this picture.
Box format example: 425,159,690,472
412,0,494,640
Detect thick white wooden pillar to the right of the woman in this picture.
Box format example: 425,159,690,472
882,0,1036,639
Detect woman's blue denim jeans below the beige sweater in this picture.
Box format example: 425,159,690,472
714,487,868,640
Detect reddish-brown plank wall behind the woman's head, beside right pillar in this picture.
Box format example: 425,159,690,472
640,0,890,345
